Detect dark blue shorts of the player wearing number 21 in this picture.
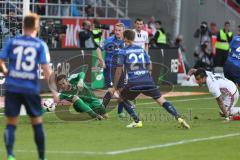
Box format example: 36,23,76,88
120,82,161,100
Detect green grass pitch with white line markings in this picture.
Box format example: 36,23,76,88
0,92,240,160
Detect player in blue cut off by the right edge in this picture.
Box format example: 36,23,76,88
223,36,240,87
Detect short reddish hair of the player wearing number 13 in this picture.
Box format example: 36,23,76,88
23,13,39,30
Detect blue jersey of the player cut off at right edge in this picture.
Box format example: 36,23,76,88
227,36,240,67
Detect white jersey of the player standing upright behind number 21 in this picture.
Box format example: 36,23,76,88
133,29,148,50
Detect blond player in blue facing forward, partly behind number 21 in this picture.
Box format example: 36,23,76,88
97,23,125,117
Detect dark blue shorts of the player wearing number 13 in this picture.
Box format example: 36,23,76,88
5,91,42,117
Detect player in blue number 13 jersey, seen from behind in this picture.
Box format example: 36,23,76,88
0,13,57,160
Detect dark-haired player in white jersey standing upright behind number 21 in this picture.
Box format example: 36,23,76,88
133,18,149,53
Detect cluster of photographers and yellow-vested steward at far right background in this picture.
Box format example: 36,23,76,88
194,21,240,72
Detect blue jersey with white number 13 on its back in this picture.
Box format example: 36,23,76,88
0,36,50,94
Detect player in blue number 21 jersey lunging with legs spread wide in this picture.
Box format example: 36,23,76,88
112,30,190,128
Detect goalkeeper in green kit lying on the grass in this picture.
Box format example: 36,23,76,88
56,72,108,120
